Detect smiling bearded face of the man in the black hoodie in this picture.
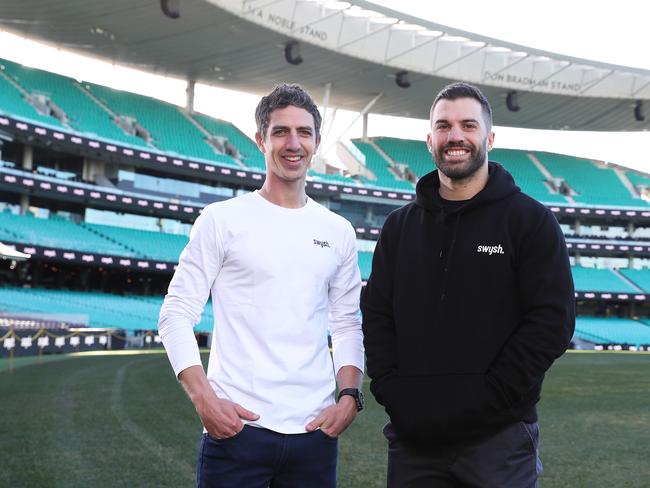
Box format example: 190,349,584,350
427,98,494,181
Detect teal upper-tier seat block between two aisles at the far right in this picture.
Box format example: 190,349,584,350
535,152,648,207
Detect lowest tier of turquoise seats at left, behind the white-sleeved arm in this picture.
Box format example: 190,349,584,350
0,287,214,331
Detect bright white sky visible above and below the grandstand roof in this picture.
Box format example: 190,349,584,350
0,0,650,173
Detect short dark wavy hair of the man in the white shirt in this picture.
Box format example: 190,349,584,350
255,83,321,137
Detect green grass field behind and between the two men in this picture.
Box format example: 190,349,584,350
0,353,650,488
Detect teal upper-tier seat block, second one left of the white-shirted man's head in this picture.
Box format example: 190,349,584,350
83,82,240,168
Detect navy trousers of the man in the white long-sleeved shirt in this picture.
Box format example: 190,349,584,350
196,425,338,488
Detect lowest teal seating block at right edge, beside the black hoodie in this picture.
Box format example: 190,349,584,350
575,317,650,346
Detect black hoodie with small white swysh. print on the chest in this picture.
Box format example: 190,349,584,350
361,162,575,444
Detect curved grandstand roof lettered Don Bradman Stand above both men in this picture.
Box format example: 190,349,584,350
0,0,650,130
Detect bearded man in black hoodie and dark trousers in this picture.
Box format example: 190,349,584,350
361,83,575,488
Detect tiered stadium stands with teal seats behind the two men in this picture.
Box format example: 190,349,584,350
0,60,650,344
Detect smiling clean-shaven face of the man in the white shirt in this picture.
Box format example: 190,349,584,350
255,105,320,183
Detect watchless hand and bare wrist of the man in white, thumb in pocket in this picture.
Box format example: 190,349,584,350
178,365,260,439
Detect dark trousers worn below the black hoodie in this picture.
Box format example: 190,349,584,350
384,422,542,488
